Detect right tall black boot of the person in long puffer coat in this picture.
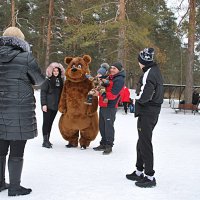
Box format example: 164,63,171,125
8,157,32,196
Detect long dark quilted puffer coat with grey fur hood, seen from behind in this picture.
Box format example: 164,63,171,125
0,36,45,140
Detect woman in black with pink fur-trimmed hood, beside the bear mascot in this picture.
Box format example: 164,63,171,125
40,62,65,148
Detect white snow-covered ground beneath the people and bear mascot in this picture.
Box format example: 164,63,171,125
0,91,200,200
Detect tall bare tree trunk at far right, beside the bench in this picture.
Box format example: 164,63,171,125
185,0,196,103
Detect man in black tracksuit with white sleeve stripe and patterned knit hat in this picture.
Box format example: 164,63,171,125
126,48,163,187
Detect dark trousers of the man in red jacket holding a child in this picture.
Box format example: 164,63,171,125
99,107,117,146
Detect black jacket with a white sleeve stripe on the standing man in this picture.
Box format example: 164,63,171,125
135,63,164,117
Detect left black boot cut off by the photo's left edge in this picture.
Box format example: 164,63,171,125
0,156,9,192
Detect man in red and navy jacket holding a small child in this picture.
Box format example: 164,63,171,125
93,62,125,155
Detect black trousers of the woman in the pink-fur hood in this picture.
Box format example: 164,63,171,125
42,109,57,135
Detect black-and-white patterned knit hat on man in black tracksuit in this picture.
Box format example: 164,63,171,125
138,48,154,65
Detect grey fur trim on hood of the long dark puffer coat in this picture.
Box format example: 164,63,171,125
0,36,30,52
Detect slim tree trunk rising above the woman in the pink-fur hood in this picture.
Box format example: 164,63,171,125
45,0,54,67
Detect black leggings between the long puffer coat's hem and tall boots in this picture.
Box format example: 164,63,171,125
0,140,27,157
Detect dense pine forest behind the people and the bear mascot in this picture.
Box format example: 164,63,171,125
0,0,200,88
